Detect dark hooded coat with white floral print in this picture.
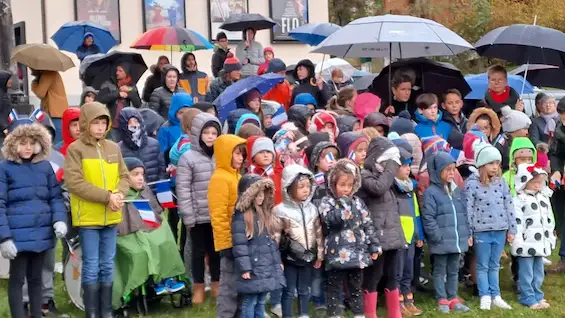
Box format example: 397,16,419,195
319,159,382,270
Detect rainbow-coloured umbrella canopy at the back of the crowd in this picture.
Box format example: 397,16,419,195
130,27,214,52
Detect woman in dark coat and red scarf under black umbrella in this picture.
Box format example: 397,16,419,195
97,64,141,142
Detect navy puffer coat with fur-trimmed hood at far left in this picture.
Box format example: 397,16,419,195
0,124,67,253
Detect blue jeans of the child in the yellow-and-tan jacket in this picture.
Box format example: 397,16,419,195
78,226,118,285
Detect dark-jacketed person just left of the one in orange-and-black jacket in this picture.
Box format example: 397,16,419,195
149,65,186,118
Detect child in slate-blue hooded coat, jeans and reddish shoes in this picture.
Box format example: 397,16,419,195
422,149,470,313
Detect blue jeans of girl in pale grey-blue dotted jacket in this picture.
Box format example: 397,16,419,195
473,231,506,297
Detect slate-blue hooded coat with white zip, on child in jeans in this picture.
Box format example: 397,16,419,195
422,152,471,254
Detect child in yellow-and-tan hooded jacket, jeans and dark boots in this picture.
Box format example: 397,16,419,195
65,102,129,317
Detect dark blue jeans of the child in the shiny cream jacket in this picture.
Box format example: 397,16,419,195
282,263,313,318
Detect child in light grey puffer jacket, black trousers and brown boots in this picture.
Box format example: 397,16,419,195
176,113,221,305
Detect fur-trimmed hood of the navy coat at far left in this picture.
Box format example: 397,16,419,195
2,123,51,163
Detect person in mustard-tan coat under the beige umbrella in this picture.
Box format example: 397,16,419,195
31,70,69,143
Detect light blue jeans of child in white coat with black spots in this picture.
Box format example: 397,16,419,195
516,257,545,307
